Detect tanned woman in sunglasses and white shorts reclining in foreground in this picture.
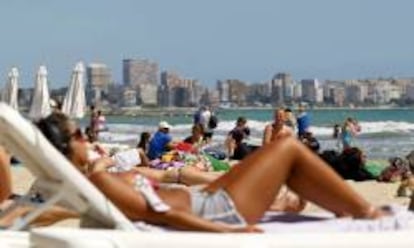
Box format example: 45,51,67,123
38,114,386,232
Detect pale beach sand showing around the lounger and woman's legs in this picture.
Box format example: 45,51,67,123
12,166,410,227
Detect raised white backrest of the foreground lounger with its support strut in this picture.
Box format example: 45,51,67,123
0,103,136,230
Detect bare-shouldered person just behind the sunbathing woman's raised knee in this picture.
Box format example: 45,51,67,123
262,109,294,145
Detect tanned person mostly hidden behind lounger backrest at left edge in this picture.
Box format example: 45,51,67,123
0,146,78,229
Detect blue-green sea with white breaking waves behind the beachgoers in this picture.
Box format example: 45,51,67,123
81,109,414,159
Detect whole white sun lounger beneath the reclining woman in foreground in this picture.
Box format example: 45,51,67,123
0,104,414,248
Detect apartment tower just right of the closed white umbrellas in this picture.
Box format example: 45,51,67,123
86,63,112,105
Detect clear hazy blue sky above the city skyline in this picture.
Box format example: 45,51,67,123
0,0,414,88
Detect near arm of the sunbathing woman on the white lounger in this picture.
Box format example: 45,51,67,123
89,171,258,232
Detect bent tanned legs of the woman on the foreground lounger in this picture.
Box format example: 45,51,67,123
205,138,373,224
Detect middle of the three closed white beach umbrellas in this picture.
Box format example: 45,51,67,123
29,66,51,120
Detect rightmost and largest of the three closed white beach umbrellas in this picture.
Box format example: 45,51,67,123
62,62,86,119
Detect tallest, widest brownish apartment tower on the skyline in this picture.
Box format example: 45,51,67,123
122,59,159,105
